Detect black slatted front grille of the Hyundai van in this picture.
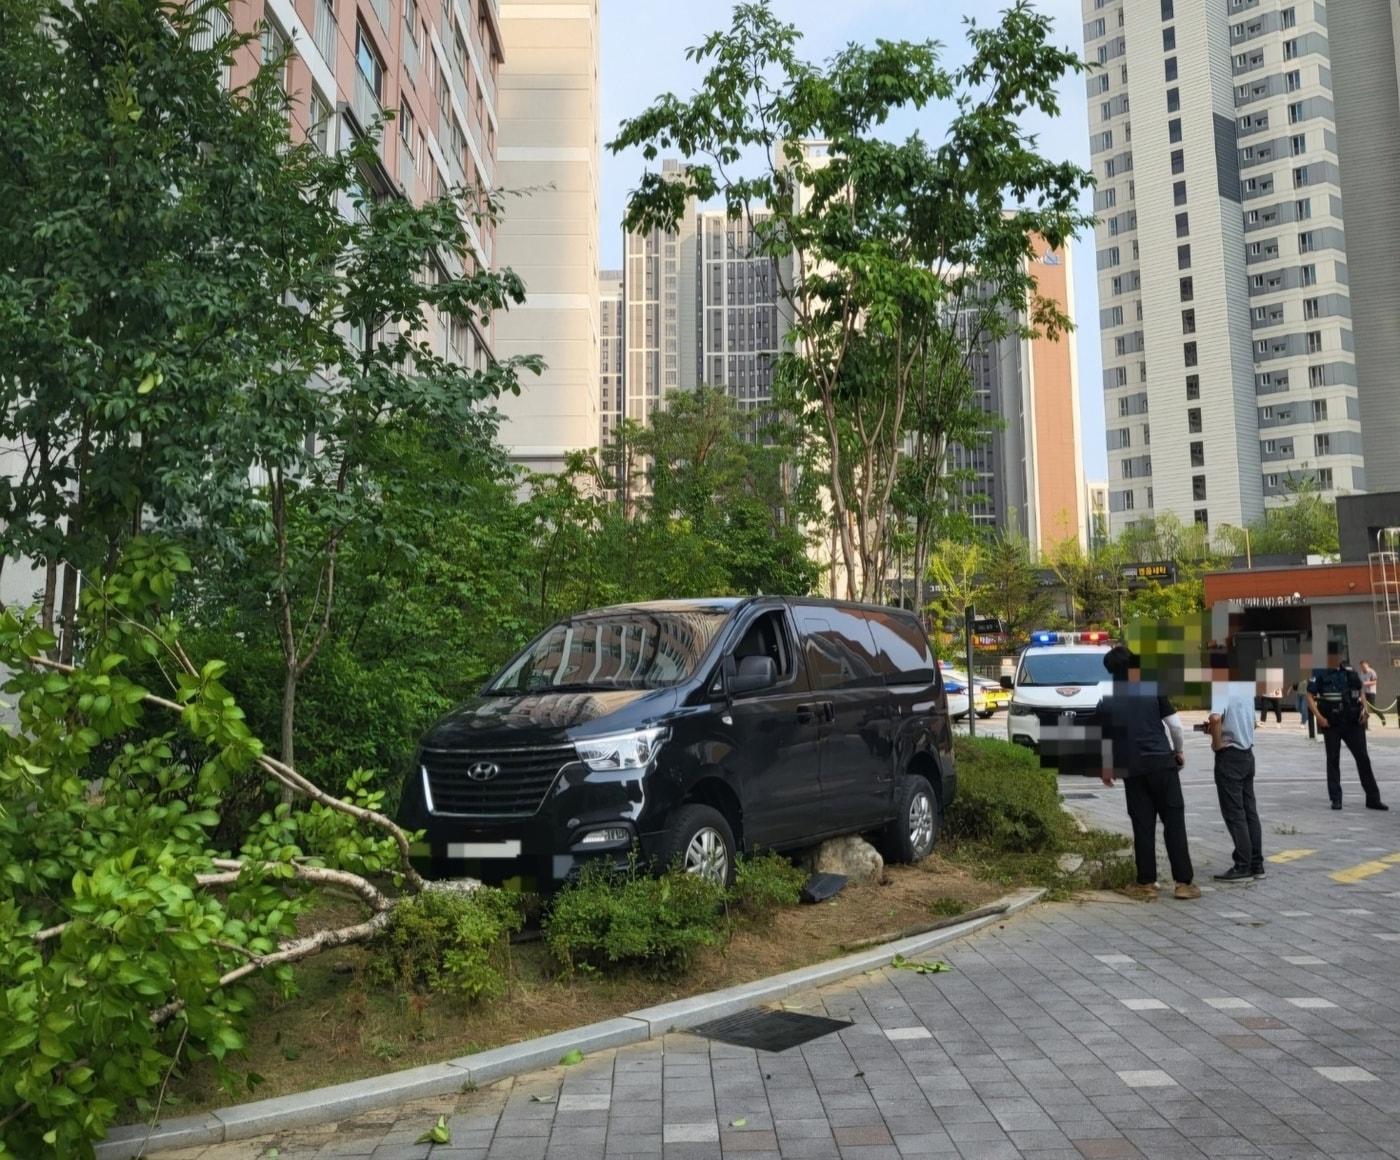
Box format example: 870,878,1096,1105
423,744,577,819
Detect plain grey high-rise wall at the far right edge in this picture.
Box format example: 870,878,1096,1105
1327,0,1400,491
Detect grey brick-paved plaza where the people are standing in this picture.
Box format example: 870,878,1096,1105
150,725,1400,1160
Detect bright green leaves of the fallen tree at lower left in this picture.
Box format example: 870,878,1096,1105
0,543,320,1157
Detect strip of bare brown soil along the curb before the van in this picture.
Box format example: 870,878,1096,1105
165,856,1004,1115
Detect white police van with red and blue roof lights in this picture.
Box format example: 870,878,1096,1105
1001,632,1113,772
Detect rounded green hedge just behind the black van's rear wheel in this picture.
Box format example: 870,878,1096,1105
944,737,1071,854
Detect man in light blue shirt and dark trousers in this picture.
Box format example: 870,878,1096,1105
1205,653,1264,882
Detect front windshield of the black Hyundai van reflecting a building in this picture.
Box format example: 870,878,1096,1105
486,609,728,694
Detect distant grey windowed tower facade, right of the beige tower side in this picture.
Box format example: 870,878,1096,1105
696,210,784,410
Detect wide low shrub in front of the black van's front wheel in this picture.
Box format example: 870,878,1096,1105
545,865,725,977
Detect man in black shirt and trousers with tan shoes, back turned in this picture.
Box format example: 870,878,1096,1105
1099,645,1201,898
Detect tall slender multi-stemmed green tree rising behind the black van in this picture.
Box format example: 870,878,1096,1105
610,3,1089,607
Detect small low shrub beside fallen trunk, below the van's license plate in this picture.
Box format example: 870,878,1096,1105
370,887,524,1003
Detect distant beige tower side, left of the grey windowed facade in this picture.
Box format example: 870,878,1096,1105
623,160,697,423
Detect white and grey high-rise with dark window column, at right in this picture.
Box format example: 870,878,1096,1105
1084,0,1366,530
